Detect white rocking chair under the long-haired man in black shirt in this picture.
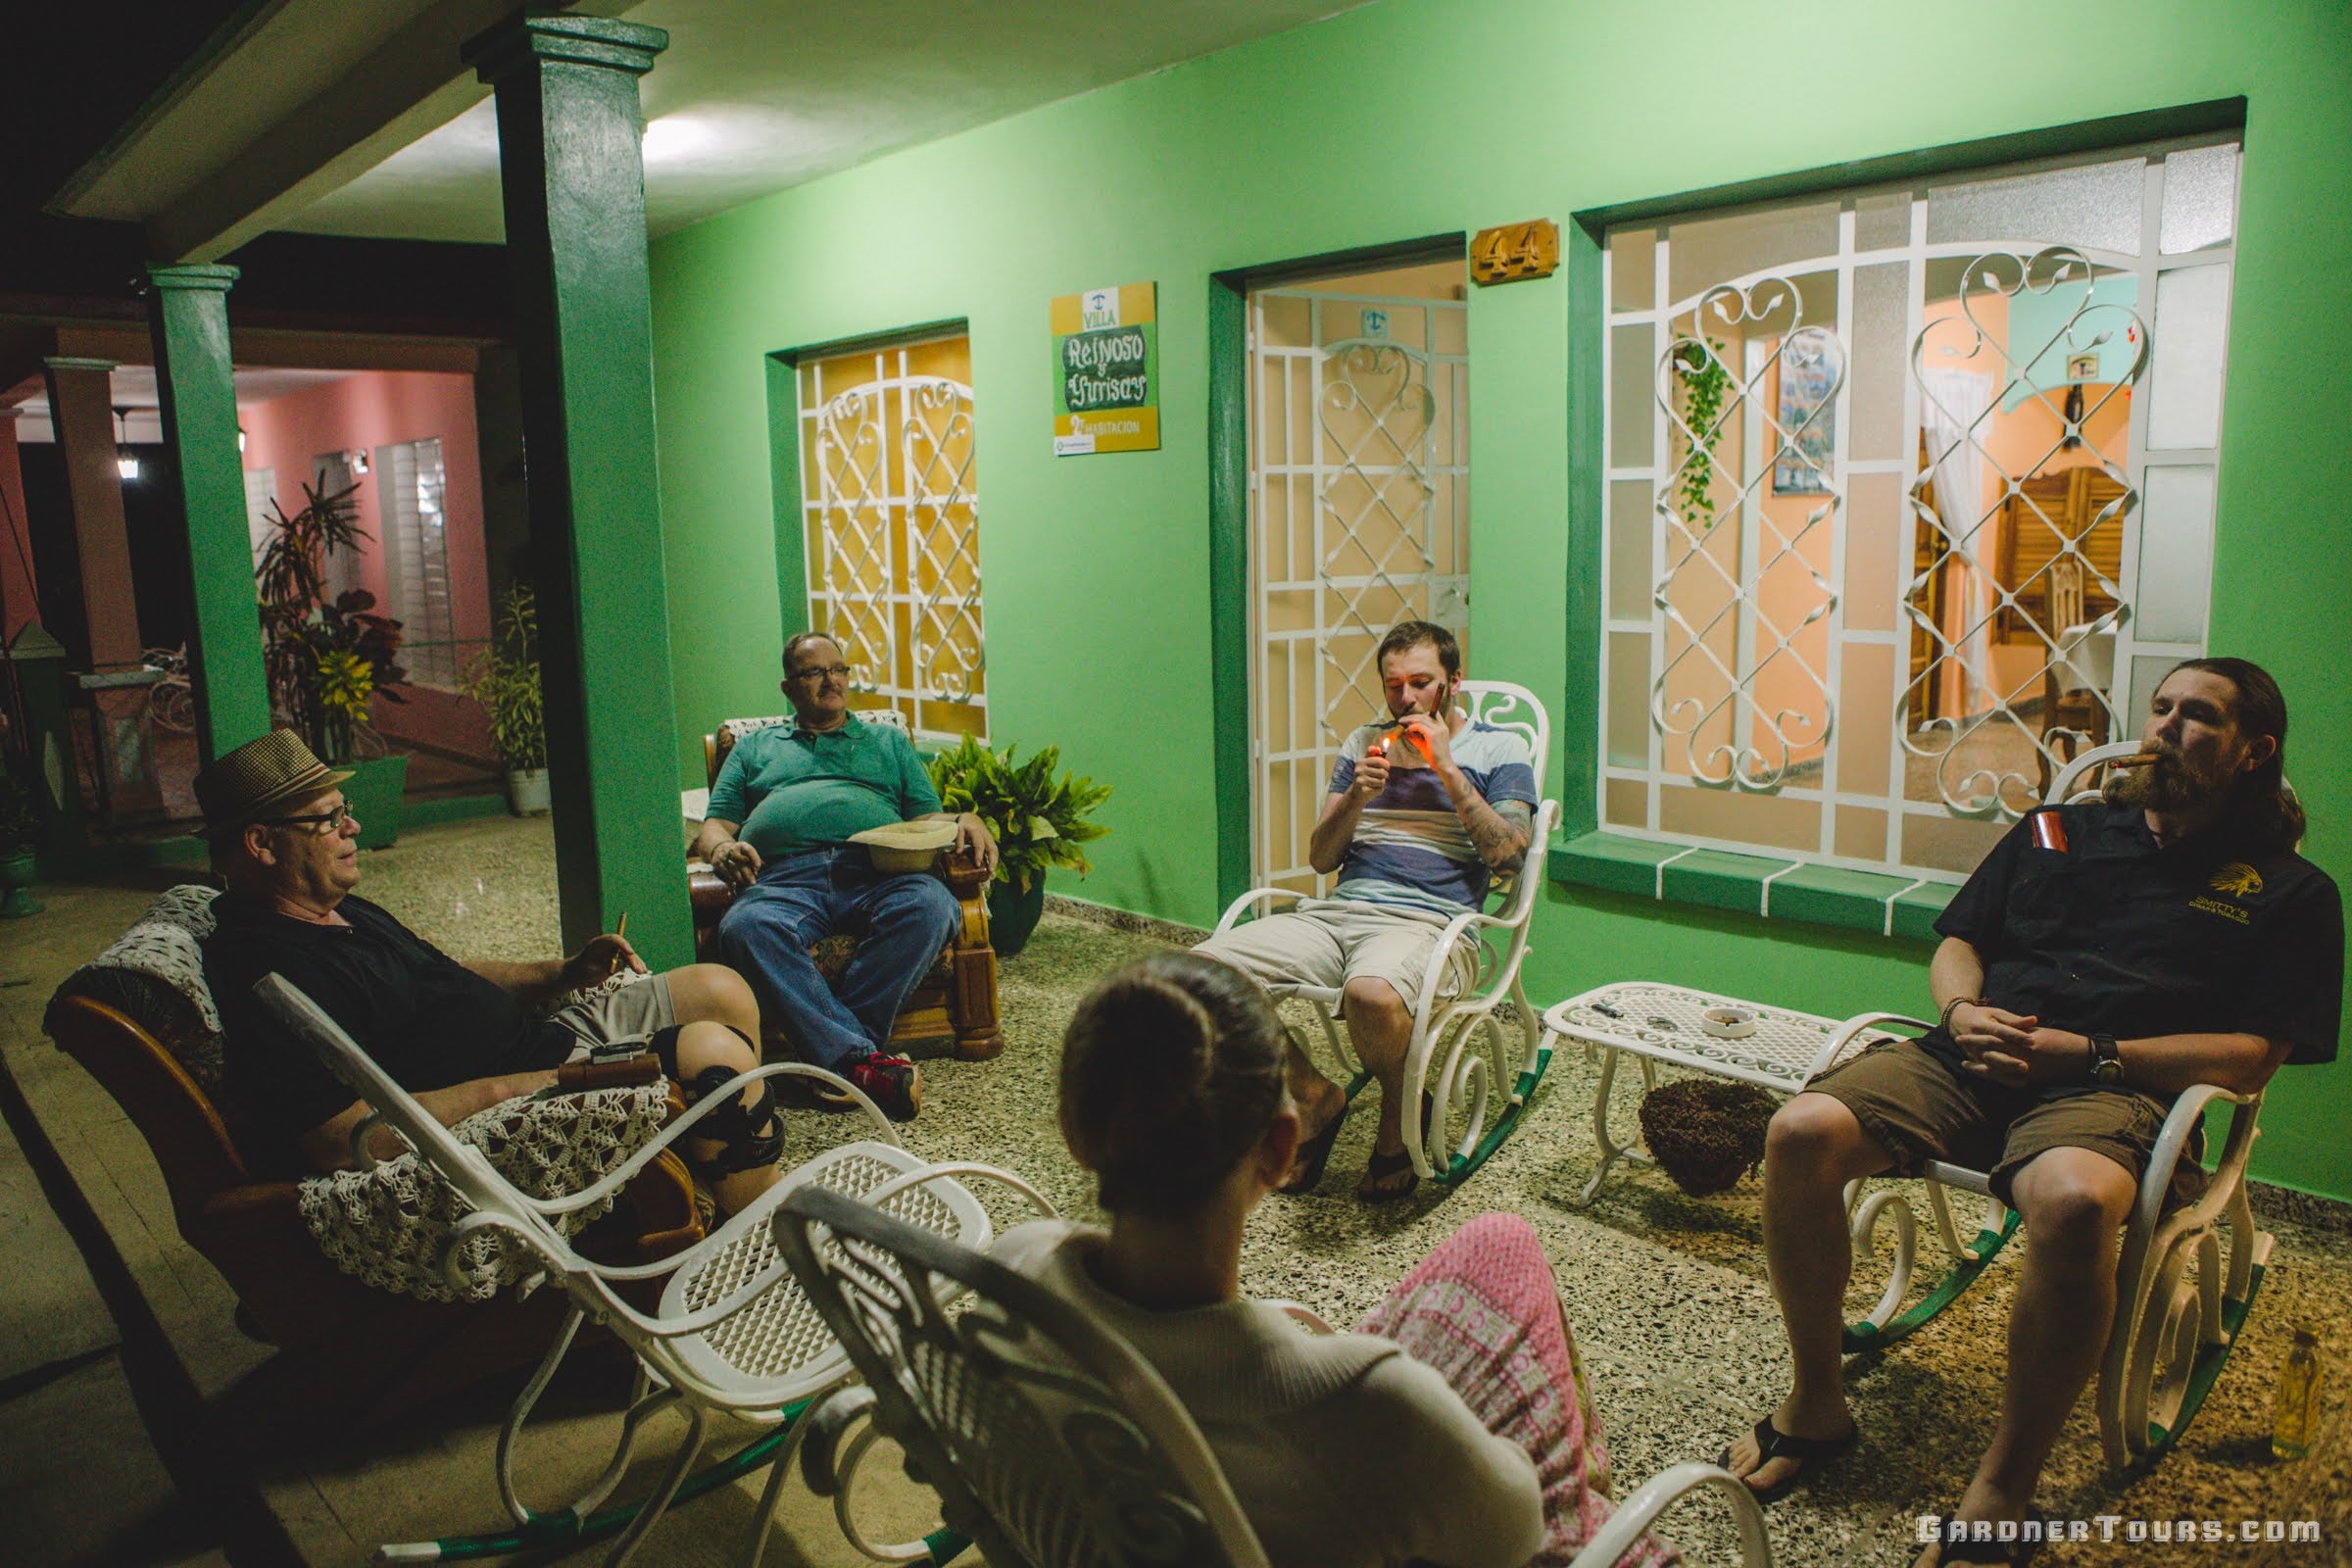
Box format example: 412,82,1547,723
1833,741,2272,1469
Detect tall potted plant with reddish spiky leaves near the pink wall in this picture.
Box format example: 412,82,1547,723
254,484,410,849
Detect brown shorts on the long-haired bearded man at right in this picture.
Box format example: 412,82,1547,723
1806,1039,2173,1206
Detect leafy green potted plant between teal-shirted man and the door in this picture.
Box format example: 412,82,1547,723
927,736,1110,956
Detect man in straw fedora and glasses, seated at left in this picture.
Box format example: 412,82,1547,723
195,729,778,1213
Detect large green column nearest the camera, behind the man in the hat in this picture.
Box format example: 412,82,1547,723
466,14,691,968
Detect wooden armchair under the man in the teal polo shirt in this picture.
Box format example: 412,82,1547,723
687,708,1004,1062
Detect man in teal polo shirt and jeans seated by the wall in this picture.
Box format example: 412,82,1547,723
694,632,998,1121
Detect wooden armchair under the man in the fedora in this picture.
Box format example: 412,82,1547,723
42,886,704,1422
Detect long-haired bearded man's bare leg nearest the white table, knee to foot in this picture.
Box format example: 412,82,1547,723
1727,1093,1893,1491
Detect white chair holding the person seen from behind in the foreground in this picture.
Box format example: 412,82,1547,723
774,1187,1771,1568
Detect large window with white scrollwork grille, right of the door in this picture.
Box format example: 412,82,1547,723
1597,143,2236,882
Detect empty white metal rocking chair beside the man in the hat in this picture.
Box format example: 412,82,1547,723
254,976,1054,1566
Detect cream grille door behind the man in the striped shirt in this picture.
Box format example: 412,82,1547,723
1249,261,1470,894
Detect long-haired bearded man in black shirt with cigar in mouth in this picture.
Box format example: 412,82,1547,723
1727,659,2345,1561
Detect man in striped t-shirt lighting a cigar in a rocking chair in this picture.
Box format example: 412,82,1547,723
1200,620,1536,1201
